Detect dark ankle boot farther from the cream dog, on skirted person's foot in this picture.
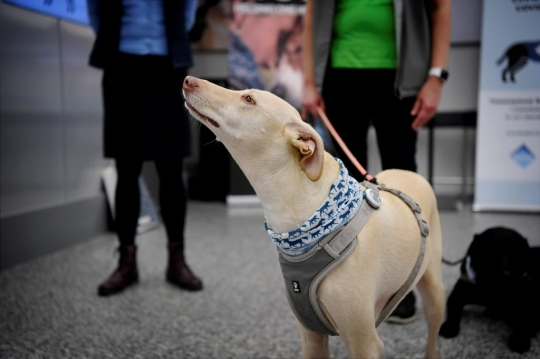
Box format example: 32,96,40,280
98,245,139,296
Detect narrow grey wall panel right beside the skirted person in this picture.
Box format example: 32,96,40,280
61,21,110,201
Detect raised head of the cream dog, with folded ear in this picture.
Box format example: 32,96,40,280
183,76,324,181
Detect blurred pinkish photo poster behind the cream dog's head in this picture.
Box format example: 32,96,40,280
228,0,306,109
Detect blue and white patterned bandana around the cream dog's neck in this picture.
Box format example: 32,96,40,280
264,158,362,255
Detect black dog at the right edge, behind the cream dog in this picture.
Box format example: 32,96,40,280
439,227,540,353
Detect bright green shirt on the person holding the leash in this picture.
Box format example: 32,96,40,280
332,0,396,69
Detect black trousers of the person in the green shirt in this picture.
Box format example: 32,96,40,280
322,67,417,180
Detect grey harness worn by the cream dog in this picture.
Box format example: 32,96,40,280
278,181,429,335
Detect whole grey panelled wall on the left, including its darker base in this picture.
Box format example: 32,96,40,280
0,3,109,269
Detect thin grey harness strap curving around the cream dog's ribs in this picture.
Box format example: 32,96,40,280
375,187,429,327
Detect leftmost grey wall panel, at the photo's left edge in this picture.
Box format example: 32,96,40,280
0,5,65,216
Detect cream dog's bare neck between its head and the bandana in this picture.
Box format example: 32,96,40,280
240,152,340,232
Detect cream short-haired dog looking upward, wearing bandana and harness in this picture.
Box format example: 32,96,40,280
184,76,445,358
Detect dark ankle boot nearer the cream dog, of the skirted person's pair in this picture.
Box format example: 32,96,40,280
167,242,202,290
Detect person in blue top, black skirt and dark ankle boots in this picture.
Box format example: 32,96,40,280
87,0,203,296
